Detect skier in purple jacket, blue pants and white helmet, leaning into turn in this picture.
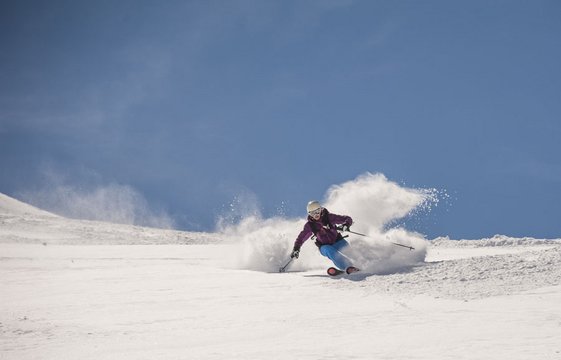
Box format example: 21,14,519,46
290,200,359,276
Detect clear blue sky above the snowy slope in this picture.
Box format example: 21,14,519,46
0,0,561,238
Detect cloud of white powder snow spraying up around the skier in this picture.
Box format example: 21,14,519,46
222,173,438,274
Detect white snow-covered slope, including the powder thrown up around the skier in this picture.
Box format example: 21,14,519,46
0,183,561,360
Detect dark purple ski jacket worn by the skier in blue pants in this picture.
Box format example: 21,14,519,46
294,209,353,250
